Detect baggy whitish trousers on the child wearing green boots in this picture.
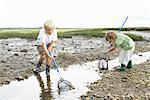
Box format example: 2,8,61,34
119,47,135,66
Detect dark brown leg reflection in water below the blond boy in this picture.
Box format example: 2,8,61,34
36,73,53,100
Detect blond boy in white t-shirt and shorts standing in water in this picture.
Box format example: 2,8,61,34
34,20,57,76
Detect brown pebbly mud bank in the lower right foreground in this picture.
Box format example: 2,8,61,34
81,60,150,100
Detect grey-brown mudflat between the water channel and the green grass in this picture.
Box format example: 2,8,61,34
0,37,150,85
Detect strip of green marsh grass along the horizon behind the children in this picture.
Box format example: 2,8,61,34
0,28,150,41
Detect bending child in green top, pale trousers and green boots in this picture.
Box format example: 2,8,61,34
105,32,135,71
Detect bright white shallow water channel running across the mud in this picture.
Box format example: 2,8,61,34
0,51,150,100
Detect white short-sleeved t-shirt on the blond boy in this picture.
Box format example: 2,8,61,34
37,29,57,45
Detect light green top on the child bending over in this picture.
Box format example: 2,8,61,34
115,33,135,50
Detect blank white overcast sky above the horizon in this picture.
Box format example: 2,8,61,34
0,0,150,28
